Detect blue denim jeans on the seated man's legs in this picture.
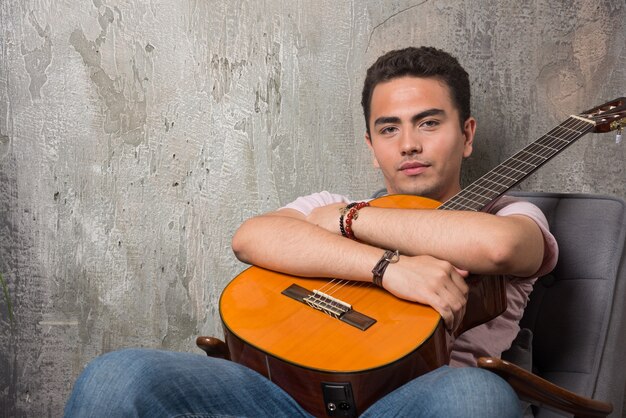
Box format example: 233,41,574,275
65,349,522,418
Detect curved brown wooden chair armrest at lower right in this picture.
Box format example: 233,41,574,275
478,357,613,417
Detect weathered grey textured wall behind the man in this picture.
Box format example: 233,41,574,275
0,0,626,417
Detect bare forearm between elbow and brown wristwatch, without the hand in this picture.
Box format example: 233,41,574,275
232,214,384,281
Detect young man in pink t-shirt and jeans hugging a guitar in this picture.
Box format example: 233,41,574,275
66,48,557,417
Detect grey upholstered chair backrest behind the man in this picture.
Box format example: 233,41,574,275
511,192,626,418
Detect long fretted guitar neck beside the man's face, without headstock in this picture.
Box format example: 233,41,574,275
439,116,595,211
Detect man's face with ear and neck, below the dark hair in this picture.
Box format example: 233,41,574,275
366,77,476,202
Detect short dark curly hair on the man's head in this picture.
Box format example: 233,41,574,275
361,46,471,135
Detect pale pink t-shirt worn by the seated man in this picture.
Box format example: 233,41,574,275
282,191,559,367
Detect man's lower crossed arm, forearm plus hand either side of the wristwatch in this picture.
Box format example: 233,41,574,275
232,210,467,329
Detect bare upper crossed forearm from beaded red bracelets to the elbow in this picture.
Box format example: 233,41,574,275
352,207,543,276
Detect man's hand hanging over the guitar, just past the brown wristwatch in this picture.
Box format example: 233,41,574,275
383,255,469,332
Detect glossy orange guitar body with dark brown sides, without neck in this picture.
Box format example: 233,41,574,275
220,195,506,416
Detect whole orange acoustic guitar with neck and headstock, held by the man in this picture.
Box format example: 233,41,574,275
219,97,626,416
